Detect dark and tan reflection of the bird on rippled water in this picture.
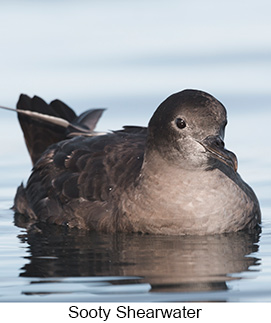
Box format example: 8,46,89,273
16,221,259,292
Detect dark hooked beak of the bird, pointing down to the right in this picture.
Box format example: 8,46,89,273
199,136,238,172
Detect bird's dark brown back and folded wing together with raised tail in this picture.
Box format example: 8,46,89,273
14,95,147,231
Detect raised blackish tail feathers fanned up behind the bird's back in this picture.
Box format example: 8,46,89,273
17,94,104,165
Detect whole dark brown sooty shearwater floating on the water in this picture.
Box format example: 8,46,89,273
5,90,261,235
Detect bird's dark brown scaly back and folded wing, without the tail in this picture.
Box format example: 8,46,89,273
14,128,146,231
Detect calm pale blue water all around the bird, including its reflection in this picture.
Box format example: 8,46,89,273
0,0,271,302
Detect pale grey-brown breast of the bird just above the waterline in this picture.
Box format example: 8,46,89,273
123,169,260,235
